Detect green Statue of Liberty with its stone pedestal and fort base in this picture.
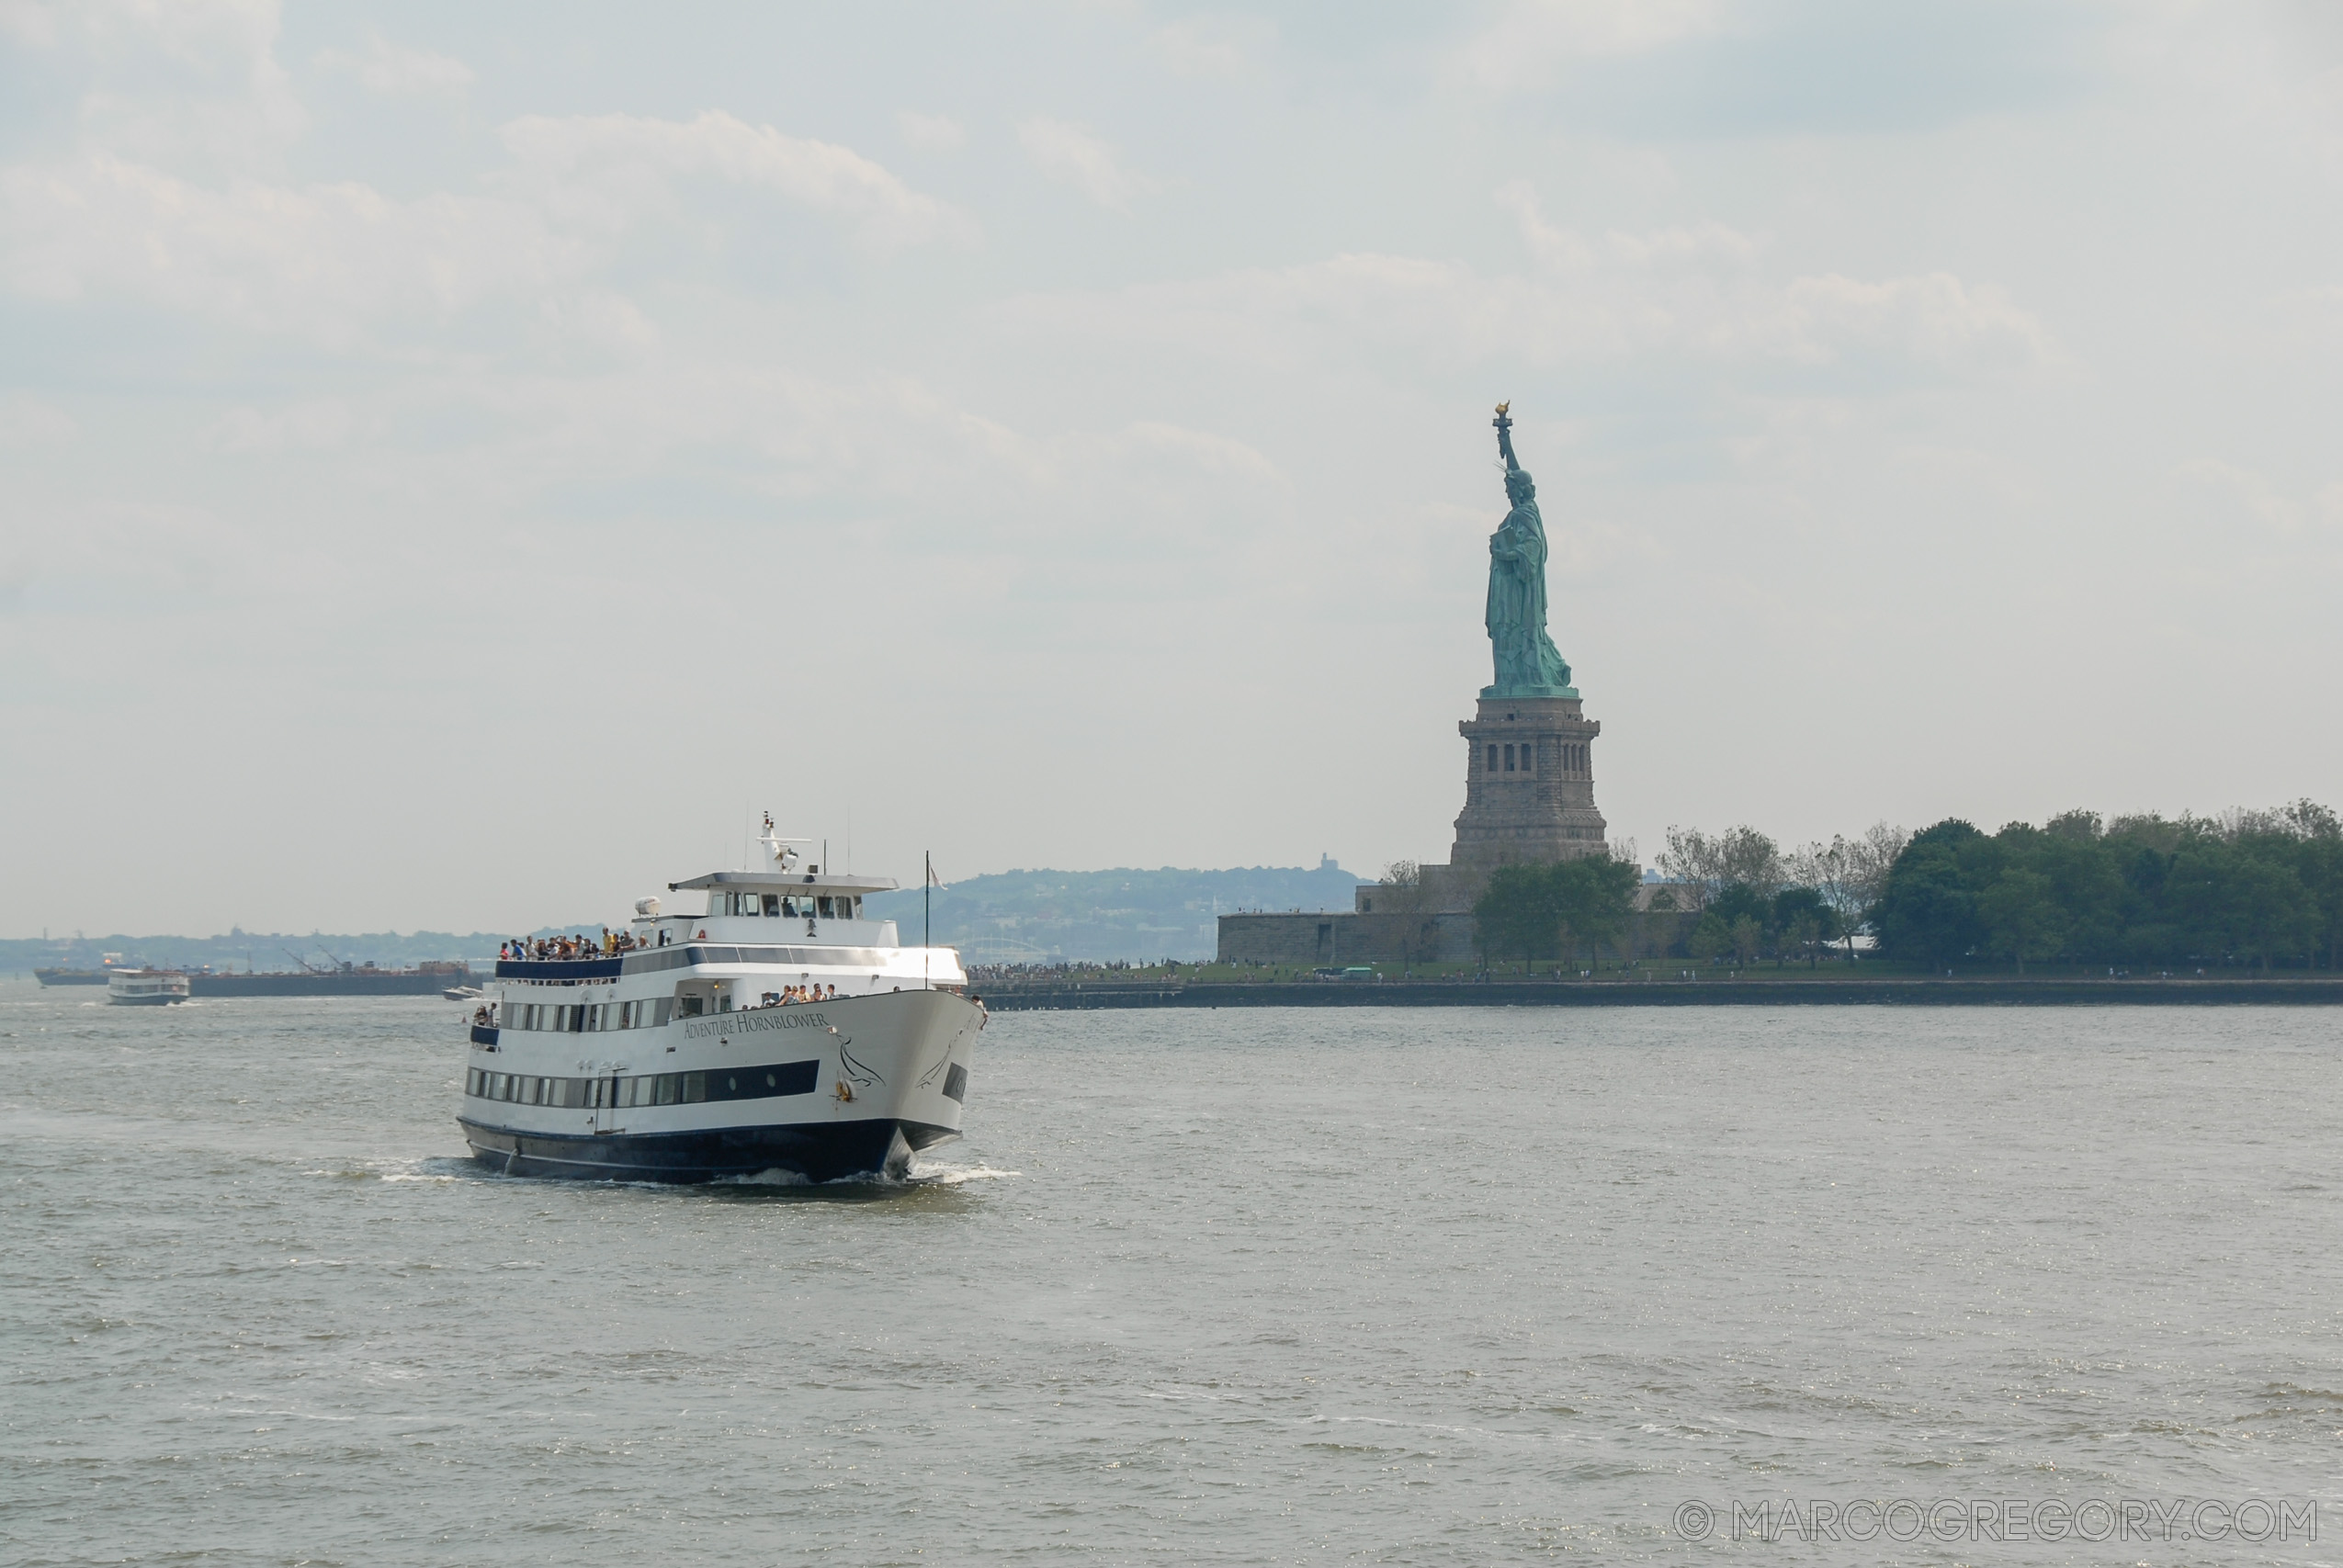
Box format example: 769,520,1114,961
1218,403,1610,964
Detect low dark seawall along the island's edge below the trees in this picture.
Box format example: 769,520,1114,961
970,977,2343,1012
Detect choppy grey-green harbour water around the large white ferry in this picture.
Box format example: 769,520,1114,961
0,982,2343,1565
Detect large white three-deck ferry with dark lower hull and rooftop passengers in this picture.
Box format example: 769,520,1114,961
457,818,984,1181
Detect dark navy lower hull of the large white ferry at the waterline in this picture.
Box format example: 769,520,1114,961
457,1118,958,1181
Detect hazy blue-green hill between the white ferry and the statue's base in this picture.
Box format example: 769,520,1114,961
862,858,1368,964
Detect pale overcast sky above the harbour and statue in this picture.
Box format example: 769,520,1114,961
0,0,2343,935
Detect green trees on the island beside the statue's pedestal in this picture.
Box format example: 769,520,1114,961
1443,799,2343,975
